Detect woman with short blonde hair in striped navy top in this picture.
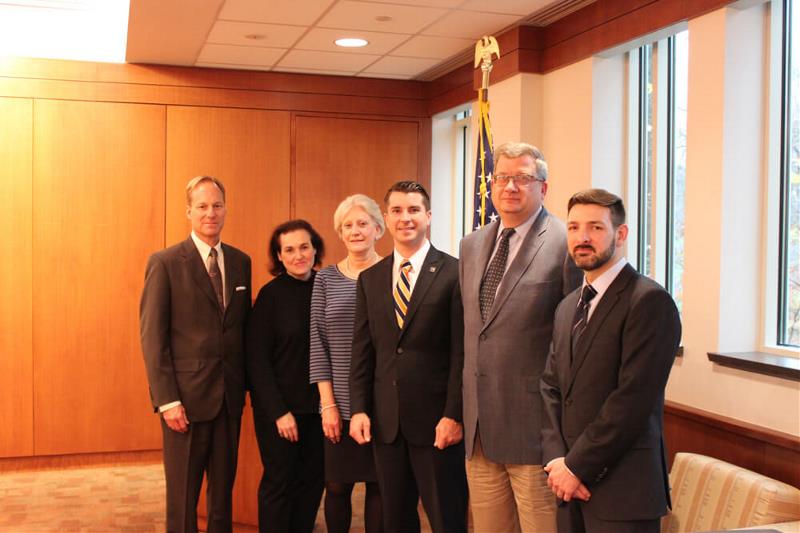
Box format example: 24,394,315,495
310,194,385,533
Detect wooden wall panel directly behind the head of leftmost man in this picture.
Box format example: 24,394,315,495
166,107,290,290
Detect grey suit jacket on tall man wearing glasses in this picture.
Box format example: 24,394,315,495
459,208,581,464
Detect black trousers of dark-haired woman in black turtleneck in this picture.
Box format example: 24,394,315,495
254,414,325,533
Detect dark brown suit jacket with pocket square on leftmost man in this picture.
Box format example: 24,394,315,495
139,238,251,422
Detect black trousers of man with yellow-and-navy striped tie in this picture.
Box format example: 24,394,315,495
373,434,467,533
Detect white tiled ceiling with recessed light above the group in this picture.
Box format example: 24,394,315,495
126,0,593,79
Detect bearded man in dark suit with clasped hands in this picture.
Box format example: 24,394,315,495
541,189,681,533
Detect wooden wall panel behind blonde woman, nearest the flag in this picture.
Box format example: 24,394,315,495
293,116,418,264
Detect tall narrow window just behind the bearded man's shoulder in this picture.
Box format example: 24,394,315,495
627,31,689,310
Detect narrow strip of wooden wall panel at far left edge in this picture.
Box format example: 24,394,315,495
0,98,33,457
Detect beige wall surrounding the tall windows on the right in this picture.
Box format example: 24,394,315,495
476,2,800,435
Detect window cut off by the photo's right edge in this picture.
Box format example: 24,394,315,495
777,0,800,347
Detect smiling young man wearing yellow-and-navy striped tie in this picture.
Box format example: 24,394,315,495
350,181,467,533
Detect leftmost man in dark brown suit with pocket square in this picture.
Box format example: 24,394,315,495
139,176,251,533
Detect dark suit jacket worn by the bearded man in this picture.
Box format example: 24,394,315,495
542,265,681,520
